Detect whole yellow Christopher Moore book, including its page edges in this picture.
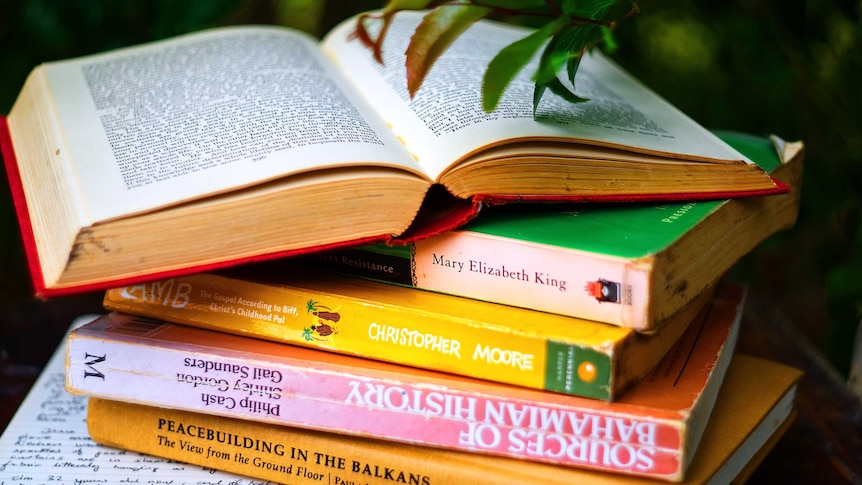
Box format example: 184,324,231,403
103,262,732,400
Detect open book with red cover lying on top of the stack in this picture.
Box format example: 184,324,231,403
0,12,787,296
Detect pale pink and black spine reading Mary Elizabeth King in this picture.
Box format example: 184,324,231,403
304,230,655,331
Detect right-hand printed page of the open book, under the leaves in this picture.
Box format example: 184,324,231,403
323,12,745,182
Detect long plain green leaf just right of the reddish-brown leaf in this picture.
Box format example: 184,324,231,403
482,17,568,113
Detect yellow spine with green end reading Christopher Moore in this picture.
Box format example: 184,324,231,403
104,274,624,400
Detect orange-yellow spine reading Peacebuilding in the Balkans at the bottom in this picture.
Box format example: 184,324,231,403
87,398,668,485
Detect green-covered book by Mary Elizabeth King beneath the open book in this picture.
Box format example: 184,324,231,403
298,133,803,332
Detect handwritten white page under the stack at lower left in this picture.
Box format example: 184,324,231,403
0,316,273,485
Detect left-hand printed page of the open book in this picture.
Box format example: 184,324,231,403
45,27,421,222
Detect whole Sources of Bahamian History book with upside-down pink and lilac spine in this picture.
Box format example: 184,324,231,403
66,286,740,480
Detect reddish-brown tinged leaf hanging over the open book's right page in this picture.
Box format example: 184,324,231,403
406,5,492,97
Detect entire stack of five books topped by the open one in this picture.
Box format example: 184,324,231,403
0,8,803,485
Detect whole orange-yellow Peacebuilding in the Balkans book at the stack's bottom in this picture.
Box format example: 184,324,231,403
87,355,801,485
